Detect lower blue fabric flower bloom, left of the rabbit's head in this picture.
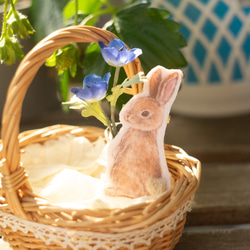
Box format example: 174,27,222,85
70,73,111,102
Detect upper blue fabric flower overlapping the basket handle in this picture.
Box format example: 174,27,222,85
99,39,142,67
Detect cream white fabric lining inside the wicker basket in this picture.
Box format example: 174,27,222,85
21,134,155,209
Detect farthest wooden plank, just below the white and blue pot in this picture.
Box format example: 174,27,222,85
165,114,250,162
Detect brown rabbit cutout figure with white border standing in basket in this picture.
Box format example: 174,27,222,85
105,66,182,198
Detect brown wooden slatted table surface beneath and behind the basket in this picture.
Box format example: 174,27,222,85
0,112,250,250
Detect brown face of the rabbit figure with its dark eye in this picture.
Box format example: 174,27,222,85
120,95,163,131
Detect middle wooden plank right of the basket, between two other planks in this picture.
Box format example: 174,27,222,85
187,163,250,225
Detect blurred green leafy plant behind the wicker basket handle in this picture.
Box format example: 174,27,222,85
0,0,186,105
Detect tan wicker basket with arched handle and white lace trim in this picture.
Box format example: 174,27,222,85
0,26,200,250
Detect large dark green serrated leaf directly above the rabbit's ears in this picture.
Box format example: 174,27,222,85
107,3,187,73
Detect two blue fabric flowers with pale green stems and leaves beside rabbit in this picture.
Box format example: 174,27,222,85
66,39,143,137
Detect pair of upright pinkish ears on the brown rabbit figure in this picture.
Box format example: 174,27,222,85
149,67,180,103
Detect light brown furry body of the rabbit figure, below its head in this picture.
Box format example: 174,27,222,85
106,118,162,197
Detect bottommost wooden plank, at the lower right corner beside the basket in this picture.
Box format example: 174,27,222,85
174,225,250,250
